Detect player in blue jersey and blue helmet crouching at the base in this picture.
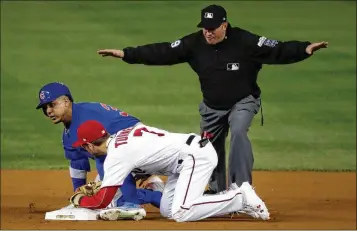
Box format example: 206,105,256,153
36,82,162,208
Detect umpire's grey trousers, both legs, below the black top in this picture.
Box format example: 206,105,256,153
199,95,260,192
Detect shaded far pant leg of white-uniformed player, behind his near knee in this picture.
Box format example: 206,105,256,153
160,174,179,219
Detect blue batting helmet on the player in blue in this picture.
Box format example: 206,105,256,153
36,82,73,109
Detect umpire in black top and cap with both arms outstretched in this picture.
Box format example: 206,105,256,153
98,5,327,193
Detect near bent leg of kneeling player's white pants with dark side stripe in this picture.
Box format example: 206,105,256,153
172,143,243,222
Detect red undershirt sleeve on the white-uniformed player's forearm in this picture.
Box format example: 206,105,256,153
79,186,119,209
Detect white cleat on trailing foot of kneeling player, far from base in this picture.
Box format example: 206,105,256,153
236,182,270,220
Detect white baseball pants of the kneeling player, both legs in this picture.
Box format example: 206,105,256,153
160,136,243,222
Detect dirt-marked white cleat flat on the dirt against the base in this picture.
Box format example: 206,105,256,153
99,207,146,221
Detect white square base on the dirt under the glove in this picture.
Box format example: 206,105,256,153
45,205,100,221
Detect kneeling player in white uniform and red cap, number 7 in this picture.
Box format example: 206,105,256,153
70,120,269,222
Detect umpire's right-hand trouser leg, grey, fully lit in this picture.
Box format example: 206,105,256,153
228,96,260,186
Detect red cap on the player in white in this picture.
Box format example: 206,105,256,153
72,120,108,148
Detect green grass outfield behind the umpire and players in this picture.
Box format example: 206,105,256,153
1,1,356,171
